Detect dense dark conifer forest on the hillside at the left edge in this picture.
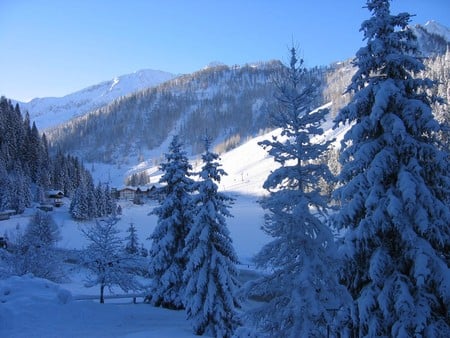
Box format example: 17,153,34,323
0,97,92,213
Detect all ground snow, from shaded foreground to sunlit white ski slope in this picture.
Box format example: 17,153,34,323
0,104,348,338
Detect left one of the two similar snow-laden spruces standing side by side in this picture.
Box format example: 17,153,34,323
149,136,193,309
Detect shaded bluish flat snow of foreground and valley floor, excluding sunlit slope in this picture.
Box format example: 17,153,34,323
0,194,268,338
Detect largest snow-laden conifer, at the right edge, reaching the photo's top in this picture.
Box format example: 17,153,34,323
335,0,450,337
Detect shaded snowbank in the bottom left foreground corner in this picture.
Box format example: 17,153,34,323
0,275,195,338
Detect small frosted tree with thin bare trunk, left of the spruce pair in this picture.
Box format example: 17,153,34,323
81,218,141,303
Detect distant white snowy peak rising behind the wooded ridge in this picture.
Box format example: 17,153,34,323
19,69,176,130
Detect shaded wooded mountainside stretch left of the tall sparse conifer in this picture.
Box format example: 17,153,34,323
47,61,300,163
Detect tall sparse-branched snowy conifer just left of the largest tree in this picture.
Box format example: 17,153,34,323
241,48,348,337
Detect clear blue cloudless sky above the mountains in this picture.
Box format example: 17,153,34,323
0,0,450,101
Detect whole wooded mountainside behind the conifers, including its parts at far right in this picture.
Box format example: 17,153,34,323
47,22,449,169
